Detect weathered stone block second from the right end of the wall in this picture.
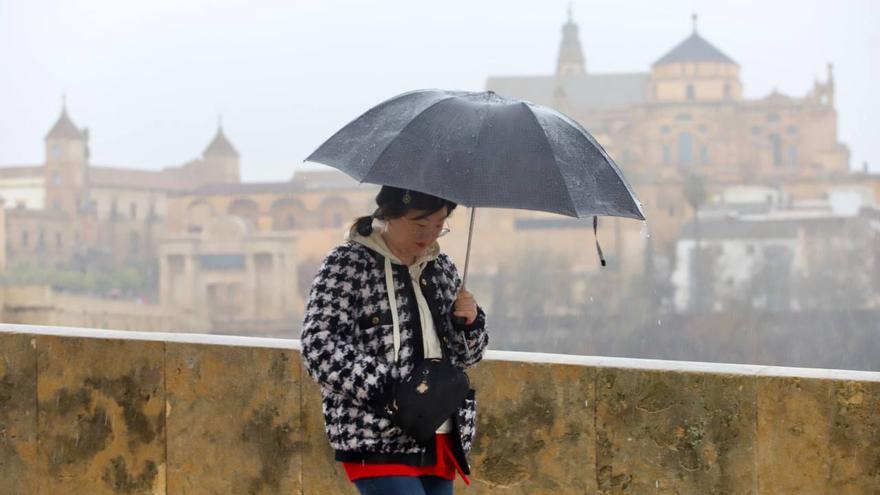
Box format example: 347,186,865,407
596,368,756,494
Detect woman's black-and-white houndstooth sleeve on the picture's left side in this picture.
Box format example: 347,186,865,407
300,245,389,401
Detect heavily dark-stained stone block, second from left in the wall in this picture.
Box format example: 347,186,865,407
36,336,165,495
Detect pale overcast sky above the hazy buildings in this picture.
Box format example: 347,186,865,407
0,0,880,181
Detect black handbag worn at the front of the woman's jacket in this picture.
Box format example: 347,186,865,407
386,358,470,445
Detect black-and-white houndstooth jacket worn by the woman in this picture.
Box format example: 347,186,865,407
301,241,488,472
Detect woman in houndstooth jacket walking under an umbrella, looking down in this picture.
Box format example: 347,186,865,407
302,186,488,495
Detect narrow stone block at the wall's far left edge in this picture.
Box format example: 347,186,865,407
0,333,37,495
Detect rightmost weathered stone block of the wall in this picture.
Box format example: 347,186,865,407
758,377,880,494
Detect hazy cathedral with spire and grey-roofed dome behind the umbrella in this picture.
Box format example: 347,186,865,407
486,12,853,247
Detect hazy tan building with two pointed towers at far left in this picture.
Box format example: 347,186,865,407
0,105,240,266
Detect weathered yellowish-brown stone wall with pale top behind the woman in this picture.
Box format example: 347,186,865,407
0,325,880,495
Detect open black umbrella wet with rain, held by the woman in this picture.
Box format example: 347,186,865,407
306,89,645,280
